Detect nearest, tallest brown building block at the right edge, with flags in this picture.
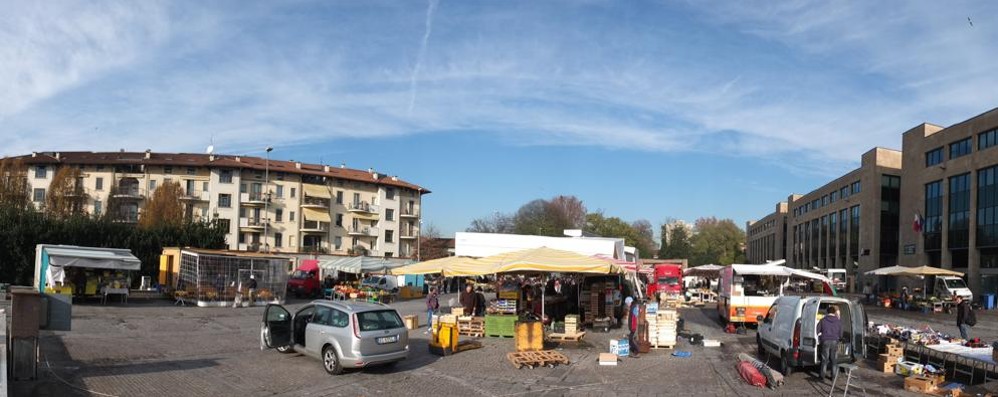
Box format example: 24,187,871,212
900,109,998,294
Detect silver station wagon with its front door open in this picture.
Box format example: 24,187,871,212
260,300,409,375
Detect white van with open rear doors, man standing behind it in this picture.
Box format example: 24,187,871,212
756,296,866,375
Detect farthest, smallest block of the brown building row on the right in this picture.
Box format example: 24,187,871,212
745,201,788,263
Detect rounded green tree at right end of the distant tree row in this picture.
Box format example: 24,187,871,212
689,217,745,266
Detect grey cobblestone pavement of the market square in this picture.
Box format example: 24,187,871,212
13,295,998,396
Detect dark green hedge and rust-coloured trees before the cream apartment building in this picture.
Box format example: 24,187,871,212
0,159,228,285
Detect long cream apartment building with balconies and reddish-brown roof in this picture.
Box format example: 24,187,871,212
18,151,430,257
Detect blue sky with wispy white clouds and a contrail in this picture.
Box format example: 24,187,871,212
0,0,998,234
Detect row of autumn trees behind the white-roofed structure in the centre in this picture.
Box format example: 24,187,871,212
467,196,745,266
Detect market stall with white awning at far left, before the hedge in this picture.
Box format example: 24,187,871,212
35,244,141,302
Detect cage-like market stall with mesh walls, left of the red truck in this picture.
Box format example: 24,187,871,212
174,248,290,307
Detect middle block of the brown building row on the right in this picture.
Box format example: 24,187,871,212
786,148,902,285
